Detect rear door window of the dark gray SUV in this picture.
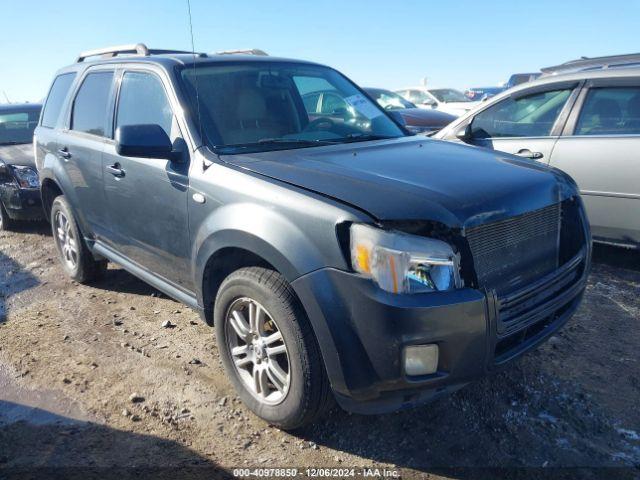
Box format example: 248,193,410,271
71,71,113,137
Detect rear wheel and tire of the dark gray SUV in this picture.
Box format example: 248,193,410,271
51,195,107,283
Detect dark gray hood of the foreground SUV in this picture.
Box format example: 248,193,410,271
221,137,577,228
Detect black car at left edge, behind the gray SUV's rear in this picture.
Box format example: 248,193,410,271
0,104,43,230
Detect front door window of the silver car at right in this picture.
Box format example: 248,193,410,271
471,88,572,139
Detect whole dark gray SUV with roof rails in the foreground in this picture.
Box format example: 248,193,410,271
35,44,591,428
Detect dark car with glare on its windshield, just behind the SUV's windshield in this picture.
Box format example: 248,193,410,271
364,88,457,135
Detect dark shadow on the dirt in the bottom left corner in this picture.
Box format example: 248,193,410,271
0,400,232,480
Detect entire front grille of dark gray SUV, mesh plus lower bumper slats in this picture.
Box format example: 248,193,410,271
466,198,589,364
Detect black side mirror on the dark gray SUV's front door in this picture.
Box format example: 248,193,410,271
116,124,174,160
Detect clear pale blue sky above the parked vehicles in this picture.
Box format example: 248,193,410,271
0,0,640,102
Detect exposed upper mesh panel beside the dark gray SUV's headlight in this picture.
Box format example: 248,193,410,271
466,203,561,294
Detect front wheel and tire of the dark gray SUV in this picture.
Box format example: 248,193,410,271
214,267,333,430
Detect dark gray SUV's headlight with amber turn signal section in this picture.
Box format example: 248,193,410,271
351,224,461,293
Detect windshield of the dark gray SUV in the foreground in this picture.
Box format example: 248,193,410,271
182,62,404,154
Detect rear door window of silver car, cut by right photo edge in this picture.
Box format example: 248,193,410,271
574,87,640,135
